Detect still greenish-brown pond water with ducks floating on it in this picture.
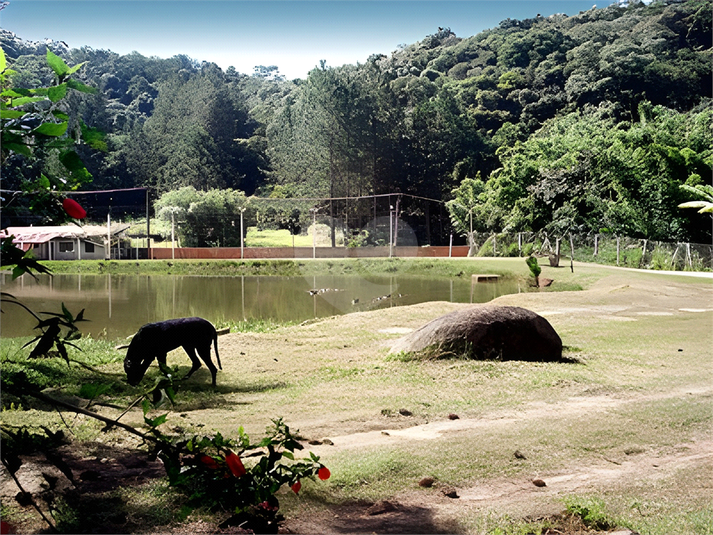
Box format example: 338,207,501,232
0,274,520,339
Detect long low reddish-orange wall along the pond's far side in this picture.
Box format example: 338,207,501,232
151,245,468,260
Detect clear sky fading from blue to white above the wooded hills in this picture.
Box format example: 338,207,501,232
0,0,612,79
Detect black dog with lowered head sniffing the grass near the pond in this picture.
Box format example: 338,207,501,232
124,318,223,386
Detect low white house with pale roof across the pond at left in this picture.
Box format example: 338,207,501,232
0,225,129,260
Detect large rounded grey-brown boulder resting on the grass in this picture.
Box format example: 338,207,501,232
391,305,562,361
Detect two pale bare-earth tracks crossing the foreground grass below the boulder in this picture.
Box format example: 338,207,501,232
289,386,713,534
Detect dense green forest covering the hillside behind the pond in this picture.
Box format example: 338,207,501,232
0,0,713,243
